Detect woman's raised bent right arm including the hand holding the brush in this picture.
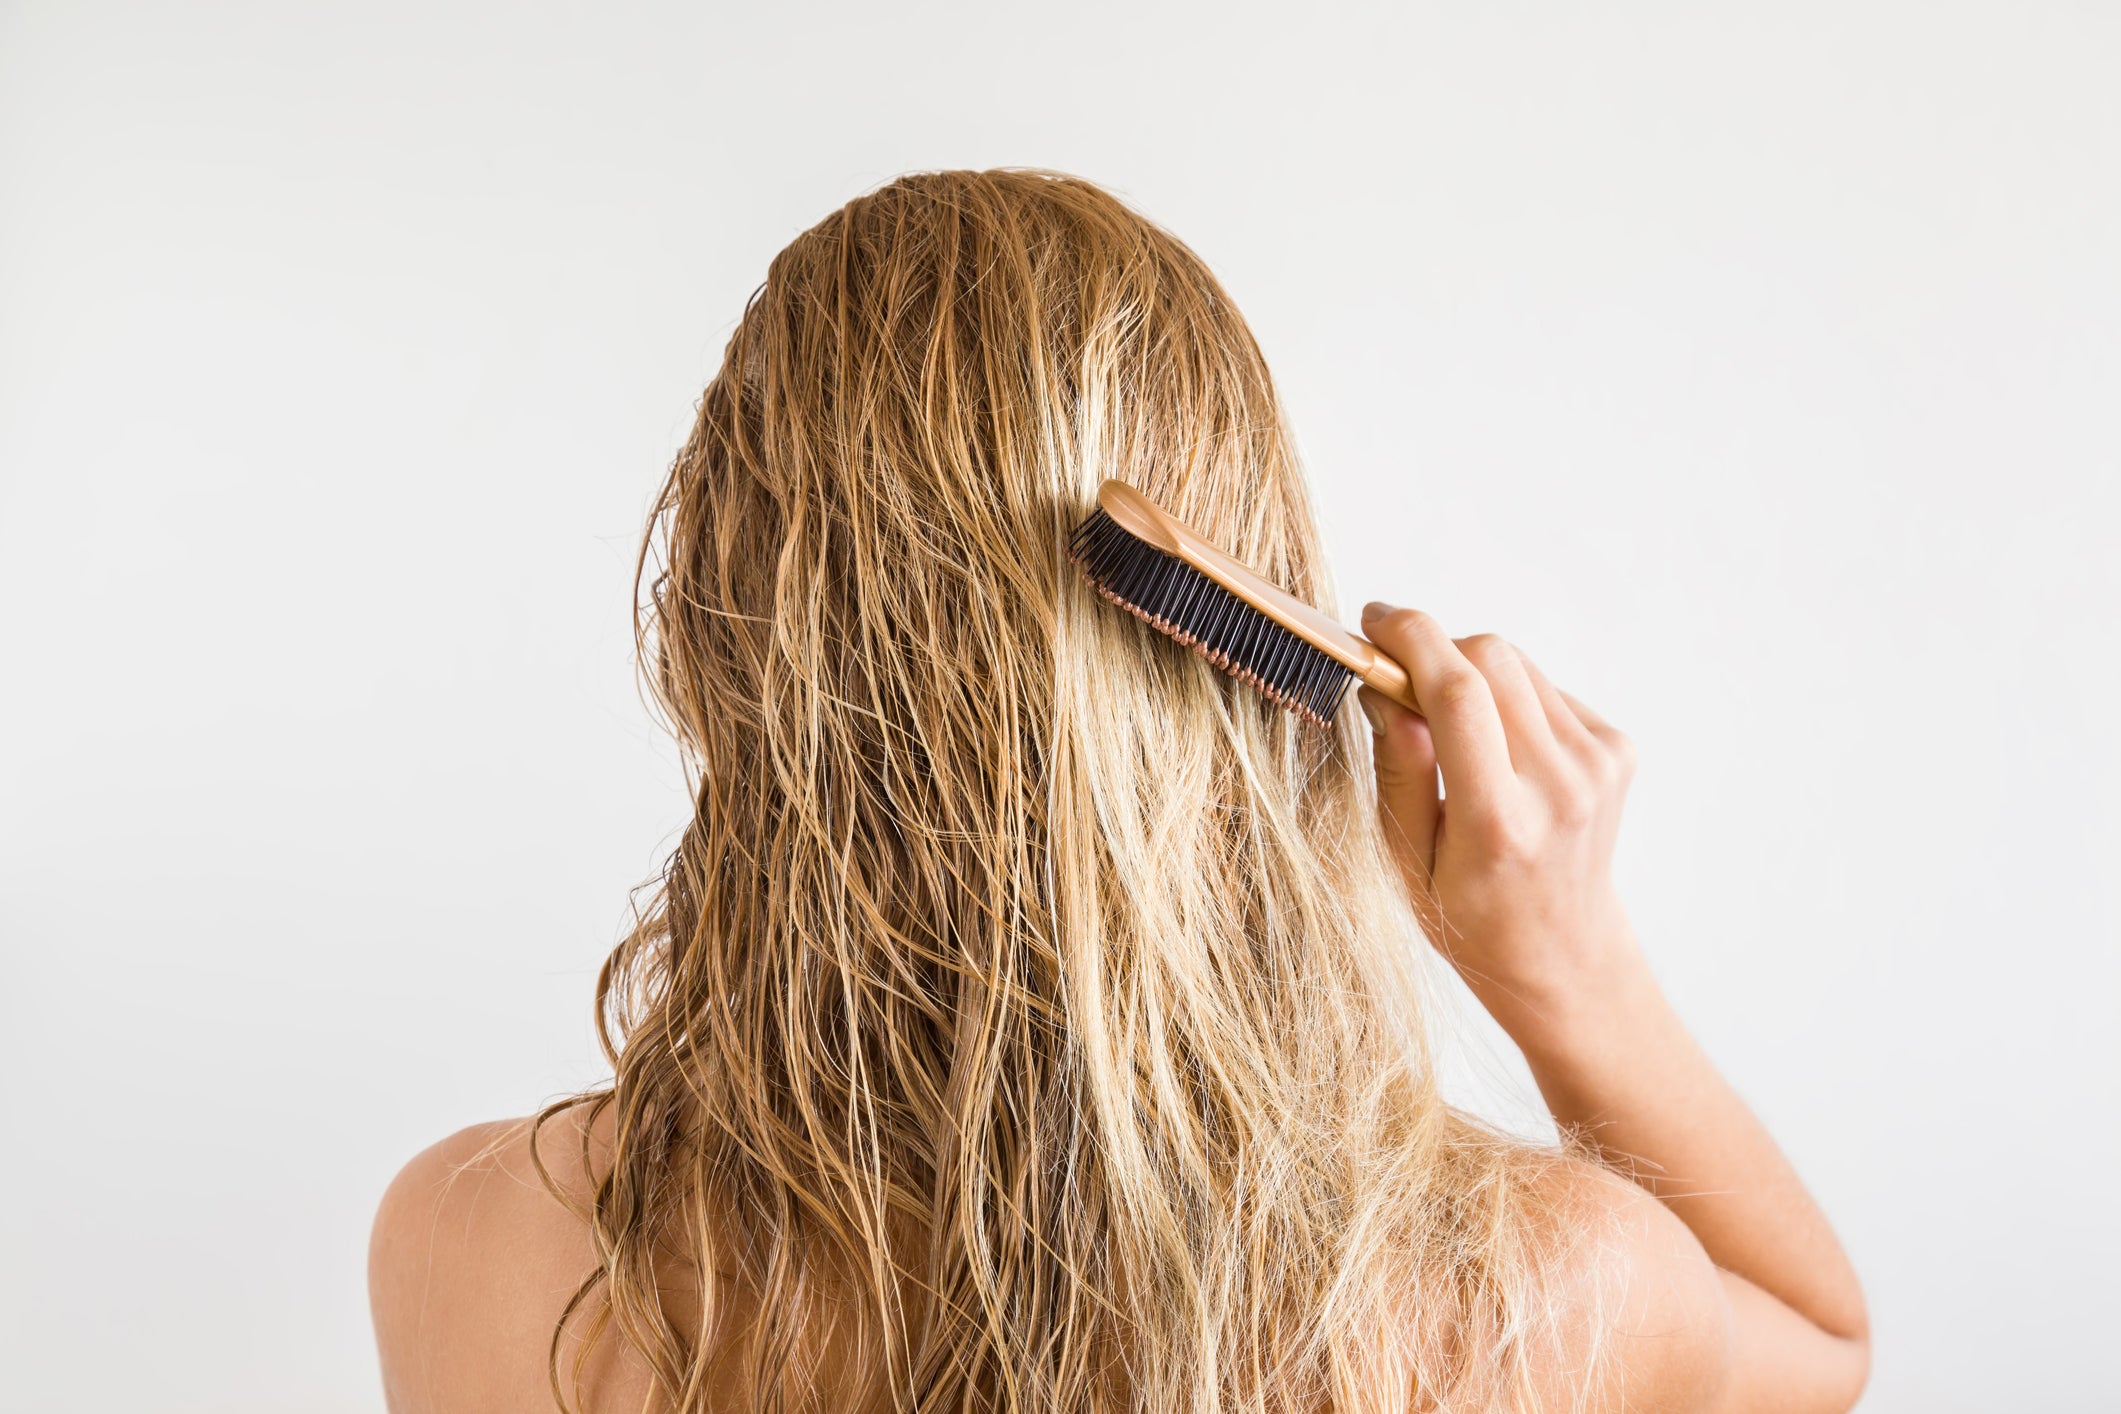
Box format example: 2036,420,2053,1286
1362,604,1869,1410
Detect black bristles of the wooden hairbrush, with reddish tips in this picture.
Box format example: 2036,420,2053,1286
1067,511,1355,727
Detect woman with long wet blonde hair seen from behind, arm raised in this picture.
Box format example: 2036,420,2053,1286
371,172,1866,1414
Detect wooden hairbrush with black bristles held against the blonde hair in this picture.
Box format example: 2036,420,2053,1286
1067,481,1421,727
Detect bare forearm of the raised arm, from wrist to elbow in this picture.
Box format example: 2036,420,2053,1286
1474,939,1866,1340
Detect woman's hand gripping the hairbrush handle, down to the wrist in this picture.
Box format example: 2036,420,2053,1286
1362,604,1635,1026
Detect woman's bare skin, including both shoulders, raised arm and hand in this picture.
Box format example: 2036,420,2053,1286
369,604,1869,1414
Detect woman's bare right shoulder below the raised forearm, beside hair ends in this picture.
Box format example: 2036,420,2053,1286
1536,1160,1733,1414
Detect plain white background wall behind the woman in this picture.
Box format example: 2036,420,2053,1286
0,0,2121,1412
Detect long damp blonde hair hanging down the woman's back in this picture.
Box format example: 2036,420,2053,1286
541,170,1586,1412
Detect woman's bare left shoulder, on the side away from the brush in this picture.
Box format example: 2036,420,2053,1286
369,1107,647,1414
